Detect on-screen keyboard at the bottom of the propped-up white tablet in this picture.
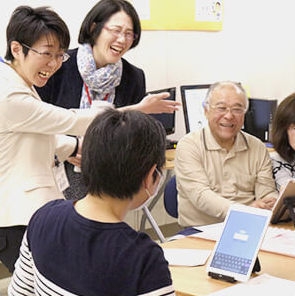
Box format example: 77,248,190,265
211,252,251,274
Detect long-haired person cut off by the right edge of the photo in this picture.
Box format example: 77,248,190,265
270,93,295,190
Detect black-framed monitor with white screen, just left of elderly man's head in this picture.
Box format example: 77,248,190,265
180,84,210,133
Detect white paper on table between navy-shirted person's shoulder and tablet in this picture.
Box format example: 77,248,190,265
163,248,211,266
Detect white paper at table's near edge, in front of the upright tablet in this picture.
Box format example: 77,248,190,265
209,274,295,296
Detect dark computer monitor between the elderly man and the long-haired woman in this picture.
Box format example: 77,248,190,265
243,98,278,142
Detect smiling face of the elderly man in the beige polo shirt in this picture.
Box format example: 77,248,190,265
205,85,246,151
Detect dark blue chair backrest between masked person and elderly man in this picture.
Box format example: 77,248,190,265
164,175,178,218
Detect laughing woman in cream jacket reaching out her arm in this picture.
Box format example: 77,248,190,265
0,6,177,272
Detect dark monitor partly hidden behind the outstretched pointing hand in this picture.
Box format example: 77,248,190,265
148,87,176,135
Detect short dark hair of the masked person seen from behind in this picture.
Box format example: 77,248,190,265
81,109,166,199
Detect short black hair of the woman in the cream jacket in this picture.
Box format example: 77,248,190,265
5,5,70,61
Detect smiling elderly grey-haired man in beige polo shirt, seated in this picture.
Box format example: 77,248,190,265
175,81,277,226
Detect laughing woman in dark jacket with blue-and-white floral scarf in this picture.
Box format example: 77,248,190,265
37,0,179,199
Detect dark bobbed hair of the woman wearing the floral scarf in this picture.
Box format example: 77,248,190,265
78,0,141,48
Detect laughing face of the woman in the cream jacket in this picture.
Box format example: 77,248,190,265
11,35,64,87
